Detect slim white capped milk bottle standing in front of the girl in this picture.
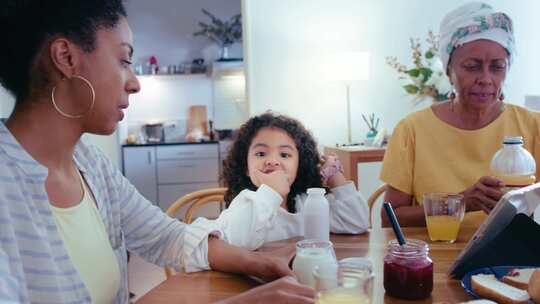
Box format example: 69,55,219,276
303,188,330,241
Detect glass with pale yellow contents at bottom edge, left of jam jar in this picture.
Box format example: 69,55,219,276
313,258,374,304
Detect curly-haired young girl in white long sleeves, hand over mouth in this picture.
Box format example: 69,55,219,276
216,113,369,250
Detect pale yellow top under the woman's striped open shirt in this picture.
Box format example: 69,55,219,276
51,171,120,303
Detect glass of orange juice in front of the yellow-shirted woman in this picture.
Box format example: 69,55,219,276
423,193,465,243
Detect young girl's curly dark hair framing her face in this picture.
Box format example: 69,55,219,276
223,112,322,213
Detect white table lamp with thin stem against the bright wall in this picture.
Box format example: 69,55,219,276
325,52,369,145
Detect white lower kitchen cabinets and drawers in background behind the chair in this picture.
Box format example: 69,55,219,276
123,143,221,218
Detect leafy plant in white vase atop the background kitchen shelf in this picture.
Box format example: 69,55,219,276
193,9,242,59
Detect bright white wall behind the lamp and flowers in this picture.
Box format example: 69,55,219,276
243,0,540,194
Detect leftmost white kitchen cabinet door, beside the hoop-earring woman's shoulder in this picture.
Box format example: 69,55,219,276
122,146,158,204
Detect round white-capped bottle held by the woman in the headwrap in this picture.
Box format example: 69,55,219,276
490,136,536,191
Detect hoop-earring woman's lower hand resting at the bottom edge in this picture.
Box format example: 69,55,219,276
220,276,315,304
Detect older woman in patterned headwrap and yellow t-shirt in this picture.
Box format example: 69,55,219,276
381,2,540,226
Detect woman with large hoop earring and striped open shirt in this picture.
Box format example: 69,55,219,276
0,0,314,303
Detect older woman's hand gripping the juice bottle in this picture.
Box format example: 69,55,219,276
461,176,504,213
